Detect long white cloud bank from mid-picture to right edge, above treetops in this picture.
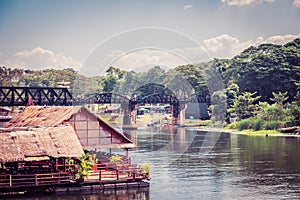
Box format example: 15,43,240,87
82,34,300,76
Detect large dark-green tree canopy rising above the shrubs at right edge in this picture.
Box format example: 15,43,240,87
223,39,300,103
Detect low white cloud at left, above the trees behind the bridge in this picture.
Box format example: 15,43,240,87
5,47,81,69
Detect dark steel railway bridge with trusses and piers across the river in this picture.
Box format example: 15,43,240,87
0,87,210,124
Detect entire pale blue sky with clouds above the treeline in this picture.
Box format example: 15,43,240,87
0,0,300,75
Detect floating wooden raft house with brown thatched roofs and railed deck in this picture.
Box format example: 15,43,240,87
0,106,149,195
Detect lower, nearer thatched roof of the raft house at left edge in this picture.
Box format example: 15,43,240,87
0,126,84,163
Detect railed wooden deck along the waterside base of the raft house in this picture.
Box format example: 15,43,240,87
0,164,149,195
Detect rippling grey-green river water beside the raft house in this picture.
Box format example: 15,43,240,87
5,128,300,200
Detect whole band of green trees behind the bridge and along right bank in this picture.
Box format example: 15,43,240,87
0,38,300,130
